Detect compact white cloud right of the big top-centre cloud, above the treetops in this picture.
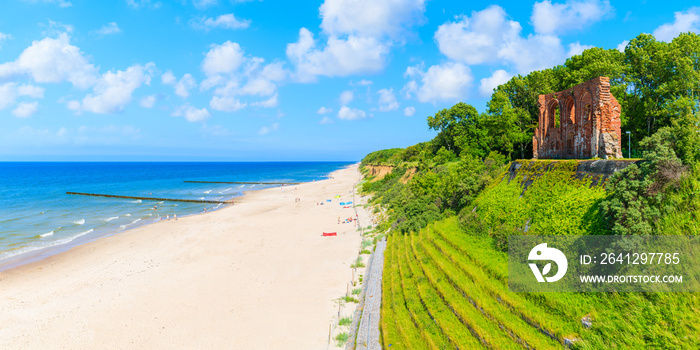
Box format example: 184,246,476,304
404,62,474,103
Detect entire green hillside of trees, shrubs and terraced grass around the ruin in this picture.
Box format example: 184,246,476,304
361,33,700,349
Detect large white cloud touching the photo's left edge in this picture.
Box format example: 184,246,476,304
0,33,98,89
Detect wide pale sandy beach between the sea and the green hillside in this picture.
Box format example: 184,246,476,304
0,165,368,349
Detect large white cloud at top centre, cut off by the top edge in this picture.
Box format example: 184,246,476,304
287,0,425,82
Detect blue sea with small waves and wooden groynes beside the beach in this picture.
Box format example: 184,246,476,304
0,162,351,271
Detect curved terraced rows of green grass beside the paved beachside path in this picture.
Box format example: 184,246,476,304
381,219,576,349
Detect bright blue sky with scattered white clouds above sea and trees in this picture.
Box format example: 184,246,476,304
0,0,700,161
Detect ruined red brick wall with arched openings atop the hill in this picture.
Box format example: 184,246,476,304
532,77,622,159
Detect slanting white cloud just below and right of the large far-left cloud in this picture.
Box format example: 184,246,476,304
68,63,155,114
